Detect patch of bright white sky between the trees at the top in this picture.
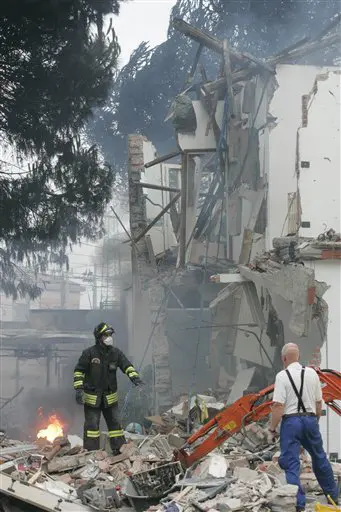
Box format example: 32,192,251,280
113,0,175,67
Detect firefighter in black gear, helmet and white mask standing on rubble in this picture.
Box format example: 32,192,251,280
73,322,142,455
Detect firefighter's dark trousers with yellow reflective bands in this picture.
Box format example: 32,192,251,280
84,404,125,454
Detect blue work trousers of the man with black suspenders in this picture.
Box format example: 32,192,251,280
278,416,338,508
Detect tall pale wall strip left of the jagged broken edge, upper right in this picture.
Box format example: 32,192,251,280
266,65,334,249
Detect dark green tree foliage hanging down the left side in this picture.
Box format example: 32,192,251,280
0,0,120,297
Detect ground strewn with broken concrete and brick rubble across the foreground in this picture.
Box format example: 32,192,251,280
0,404,341,512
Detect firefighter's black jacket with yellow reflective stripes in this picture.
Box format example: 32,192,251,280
73,344,139,407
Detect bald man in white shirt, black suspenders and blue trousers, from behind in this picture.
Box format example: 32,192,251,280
270,343,338,511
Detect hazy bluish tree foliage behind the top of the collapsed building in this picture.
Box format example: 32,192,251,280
89,0,339,180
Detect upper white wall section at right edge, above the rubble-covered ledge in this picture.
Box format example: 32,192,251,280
299,71,341,238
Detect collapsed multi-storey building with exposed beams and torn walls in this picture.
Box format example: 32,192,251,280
128,20,341,454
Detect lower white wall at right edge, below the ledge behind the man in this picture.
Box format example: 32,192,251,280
306,260,341,458
